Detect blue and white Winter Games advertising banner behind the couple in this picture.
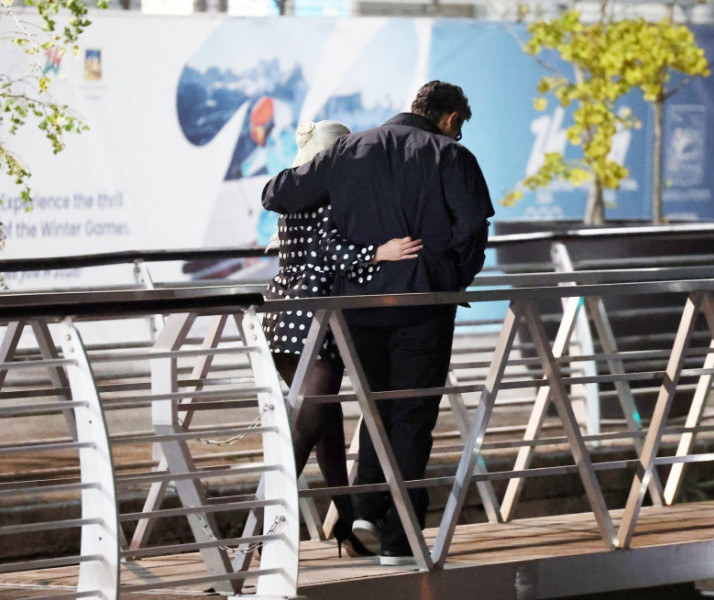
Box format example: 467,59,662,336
0,13,714,298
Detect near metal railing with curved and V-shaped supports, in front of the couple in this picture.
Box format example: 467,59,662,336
0,267,714,597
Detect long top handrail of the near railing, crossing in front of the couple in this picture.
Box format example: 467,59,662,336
0,266,714,320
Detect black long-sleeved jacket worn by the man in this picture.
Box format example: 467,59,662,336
263,113,494,328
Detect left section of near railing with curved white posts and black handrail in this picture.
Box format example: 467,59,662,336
0,287,299,598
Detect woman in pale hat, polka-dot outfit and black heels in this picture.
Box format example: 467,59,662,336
263,121,421,556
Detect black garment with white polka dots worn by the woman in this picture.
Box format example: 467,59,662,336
263,205,379,362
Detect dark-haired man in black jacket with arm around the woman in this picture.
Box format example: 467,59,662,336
263,81,494,564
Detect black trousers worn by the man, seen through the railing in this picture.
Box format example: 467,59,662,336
350,306,456,554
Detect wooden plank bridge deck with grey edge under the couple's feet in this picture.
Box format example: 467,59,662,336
0,502,714,600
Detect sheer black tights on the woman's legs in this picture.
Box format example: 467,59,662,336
273,354,354,523
